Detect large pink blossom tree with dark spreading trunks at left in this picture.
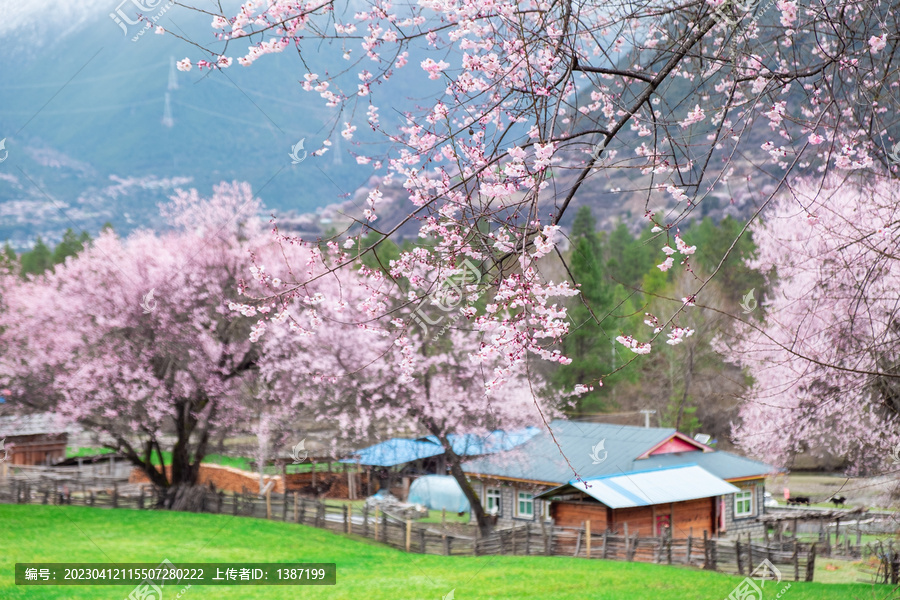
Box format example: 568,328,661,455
0,184,302,507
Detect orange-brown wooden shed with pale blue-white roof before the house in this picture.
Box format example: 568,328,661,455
537,465,738,536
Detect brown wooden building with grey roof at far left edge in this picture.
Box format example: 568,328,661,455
0,413,69,466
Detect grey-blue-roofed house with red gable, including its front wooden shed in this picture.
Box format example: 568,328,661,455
463,419,777,535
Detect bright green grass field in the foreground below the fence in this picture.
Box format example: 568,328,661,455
0,505,897,600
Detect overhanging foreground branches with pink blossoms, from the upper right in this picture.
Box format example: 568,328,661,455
162,0,900,392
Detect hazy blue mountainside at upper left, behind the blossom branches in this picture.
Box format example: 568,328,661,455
0,0,440,248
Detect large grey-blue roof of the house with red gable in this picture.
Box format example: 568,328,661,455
463,419,776,484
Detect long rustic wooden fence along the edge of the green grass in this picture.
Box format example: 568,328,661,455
0,478,816,581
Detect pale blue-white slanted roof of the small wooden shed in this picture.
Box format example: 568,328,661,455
538,465,740,508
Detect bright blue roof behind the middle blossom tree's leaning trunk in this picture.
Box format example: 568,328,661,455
341,427,540,467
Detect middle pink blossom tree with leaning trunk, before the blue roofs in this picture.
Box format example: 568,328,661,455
239,246,560,531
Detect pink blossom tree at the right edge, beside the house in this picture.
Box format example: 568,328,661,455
720,178,900,474
